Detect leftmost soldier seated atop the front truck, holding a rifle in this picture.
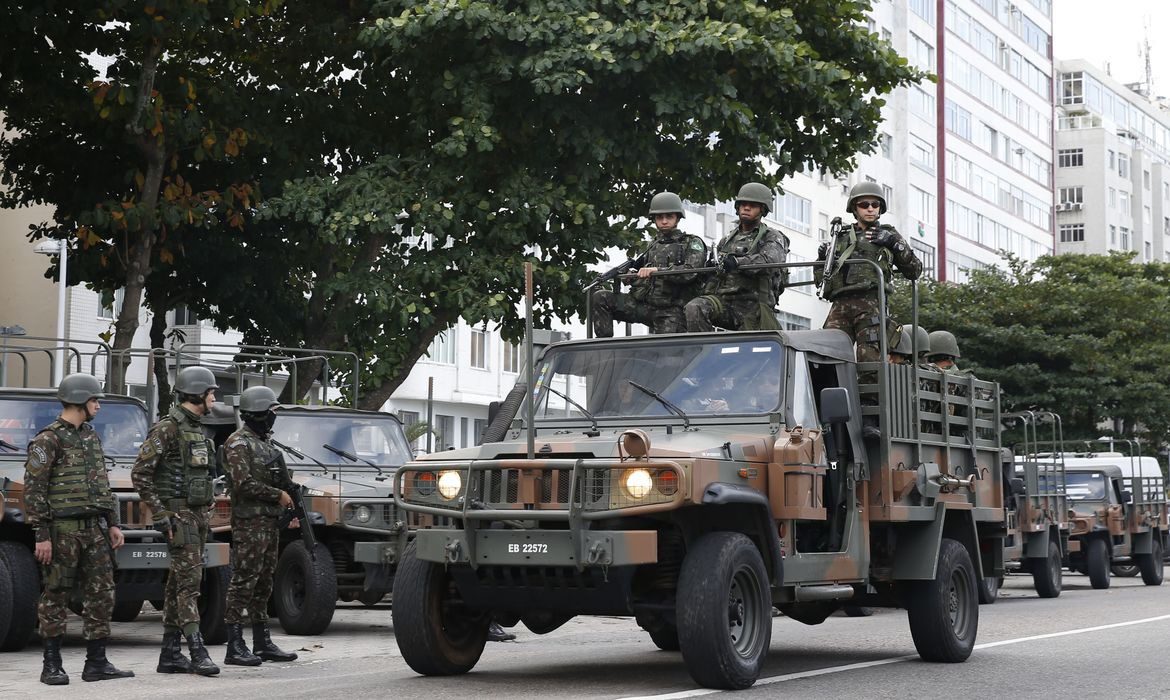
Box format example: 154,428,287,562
593,192,707,338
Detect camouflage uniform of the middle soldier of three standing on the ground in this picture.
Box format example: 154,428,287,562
130,406,215,634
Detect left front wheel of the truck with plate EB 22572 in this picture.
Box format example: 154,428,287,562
391,542,491,675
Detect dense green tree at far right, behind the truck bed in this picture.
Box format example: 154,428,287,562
894,253,1170,446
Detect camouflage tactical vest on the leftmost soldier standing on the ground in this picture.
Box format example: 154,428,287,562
37,420,116,519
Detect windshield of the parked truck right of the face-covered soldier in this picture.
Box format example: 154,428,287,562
273,411,411,469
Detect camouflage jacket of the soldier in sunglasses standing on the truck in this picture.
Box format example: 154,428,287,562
814,224,922,301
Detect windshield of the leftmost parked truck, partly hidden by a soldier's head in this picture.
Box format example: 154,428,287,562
0,397,149,457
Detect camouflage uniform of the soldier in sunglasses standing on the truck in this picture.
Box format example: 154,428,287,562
815,224,922,362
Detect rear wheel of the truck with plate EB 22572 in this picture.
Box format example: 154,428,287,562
907,537,979,664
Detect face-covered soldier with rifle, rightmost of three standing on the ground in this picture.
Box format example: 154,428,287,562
223,386,297,666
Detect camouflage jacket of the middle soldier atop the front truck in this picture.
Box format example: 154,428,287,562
704,221,789,307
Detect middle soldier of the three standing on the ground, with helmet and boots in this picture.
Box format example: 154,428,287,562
131,366,219,675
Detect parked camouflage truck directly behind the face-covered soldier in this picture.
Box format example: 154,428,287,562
260,406,411,634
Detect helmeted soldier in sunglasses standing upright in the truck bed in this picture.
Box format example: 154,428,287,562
815,183,922,362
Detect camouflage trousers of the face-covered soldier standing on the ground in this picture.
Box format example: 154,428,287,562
223,515,281,625
